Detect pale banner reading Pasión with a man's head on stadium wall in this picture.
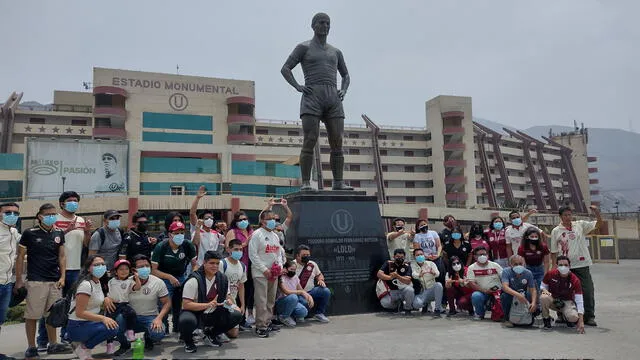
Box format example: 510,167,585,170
25,139,129,199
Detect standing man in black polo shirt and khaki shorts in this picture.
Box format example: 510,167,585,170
15,204,67,358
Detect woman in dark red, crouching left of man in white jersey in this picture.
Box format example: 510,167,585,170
445,256,473,316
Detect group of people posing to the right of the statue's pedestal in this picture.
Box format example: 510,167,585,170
376,206,602,333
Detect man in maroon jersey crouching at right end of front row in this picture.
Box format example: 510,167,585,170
540,255,585,334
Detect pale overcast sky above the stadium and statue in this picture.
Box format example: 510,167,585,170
0,0,640,131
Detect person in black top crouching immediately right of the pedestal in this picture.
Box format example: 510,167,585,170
378,249,415,315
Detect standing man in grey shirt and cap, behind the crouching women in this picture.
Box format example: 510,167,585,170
89,210,124,269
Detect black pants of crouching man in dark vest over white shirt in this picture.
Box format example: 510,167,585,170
179,307,242,344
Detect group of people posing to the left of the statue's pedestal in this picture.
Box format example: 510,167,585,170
0,187,331,360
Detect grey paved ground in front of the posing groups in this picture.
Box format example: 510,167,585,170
0,260,640,359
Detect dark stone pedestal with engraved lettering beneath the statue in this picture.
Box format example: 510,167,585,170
285,191,388,315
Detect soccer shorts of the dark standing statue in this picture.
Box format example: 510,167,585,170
300,85,344,119
